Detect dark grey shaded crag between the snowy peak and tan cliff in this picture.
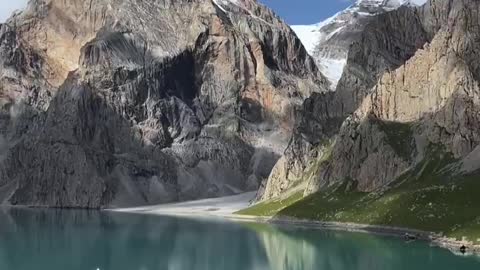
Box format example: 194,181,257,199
336,7,429,116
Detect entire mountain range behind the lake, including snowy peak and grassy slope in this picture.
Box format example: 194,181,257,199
0,0,480,244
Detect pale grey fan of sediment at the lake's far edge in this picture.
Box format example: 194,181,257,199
110,192,256,217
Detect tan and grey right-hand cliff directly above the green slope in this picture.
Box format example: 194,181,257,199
307,0,480,193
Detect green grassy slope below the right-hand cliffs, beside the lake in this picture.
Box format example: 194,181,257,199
239,147,480,243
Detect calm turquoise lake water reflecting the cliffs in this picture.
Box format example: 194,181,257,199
0,209,480,270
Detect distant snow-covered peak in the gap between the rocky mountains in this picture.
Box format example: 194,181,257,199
292,0,426,90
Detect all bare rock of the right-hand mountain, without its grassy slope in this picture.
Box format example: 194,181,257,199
261,0,480,200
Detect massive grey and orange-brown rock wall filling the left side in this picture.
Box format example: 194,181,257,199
0,0,326,208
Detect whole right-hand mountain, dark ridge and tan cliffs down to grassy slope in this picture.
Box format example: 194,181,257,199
248,0,480,244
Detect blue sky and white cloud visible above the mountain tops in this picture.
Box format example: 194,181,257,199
0,0,351,25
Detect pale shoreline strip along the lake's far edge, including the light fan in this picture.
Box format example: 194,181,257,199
3,193,480,256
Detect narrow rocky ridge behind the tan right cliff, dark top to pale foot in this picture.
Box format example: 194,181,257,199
259,6,429,200
